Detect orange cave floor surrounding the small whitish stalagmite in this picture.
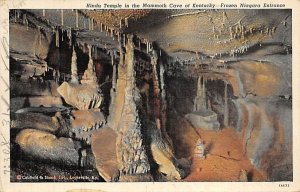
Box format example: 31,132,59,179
169,117,266,182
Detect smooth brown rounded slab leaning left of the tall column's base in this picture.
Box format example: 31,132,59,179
91,127,119,181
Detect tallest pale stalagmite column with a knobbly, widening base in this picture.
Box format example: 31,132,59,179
116,37,150,179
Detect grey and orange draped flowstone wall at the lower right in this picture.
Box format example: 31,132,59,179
235,98,293,181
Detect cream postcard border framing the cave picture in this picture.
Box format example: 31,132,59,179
0,0,300,192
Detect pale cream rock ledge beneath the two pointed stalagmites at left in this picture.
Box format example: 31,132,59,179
57,82,103,110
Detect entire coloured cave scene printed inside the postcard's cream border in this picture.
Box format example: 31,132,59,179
9,9,293,182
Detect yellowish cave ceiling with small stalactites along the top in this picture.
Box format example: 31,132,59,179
26,10,291,60
